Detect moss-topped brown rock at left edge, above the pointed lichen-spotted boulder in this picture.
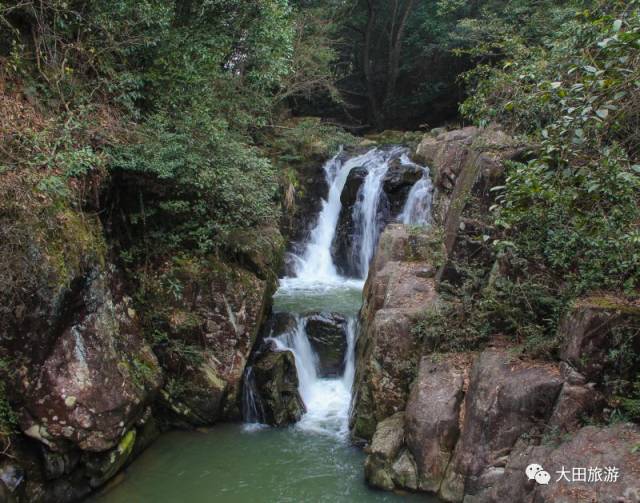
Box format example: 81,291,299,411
0,200,106,401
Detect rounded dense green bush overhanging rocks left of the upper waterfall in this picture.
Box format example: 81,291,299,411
114,114,278,253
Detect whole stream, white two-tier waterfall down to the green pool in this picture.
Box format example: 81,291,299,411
92,147,437,503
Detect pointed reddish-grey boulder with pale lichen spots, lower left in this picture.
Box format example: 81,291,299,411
21,270,161,452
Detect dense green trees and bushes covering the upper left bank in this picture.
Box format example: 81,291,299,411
0,0,338,265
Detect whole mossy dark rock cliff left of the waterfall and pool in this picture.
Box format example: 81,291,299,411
0,173,283,503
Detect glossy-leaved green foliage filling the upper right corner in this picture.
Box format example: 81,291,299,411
462,2,640,295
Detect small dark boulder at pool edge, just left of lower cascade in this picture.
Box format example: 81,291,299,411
252,351,306,426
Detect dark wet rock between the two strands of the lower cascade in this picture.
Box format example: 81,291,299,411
305,313,348,377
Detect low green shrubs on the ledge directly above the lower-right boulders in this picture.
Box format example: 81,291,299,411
413,256,567,358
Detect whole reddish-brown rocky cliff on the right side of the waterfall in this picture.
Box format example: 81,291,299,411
351,128,640,503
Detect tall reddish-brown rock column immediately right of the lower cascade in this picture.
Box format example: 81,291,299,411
350,225,440,439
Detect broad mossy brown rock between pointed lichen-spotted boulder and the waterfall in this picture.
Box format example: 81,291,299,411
145,252,282,426
